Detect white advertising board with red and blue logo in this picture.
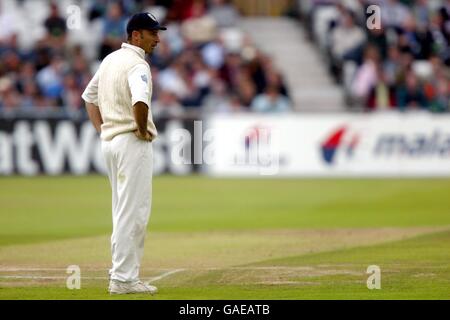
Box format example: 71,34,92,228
203,113,450,177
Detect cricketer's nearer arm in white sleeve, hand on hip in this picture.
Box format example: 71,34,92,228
128,64,153,141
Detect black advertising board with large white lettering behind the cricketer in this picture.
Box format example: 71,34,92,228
0,117,198,177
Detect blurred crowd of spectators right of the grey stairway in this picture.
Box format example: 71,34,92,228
305,0,450,112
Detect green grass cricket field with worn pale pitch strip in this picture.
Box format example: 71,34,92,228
0,176,450,299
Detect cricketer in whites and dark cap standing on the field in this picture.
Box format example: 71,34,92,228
82,13,166,294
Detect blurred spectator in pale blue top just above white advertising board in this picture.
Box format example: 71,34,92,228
251,86,291,113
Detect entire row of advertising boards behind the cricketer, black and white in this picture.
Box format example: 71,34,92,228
0,113,450,177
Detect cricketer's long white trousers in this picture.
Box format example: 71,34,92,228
102,132,153,282
